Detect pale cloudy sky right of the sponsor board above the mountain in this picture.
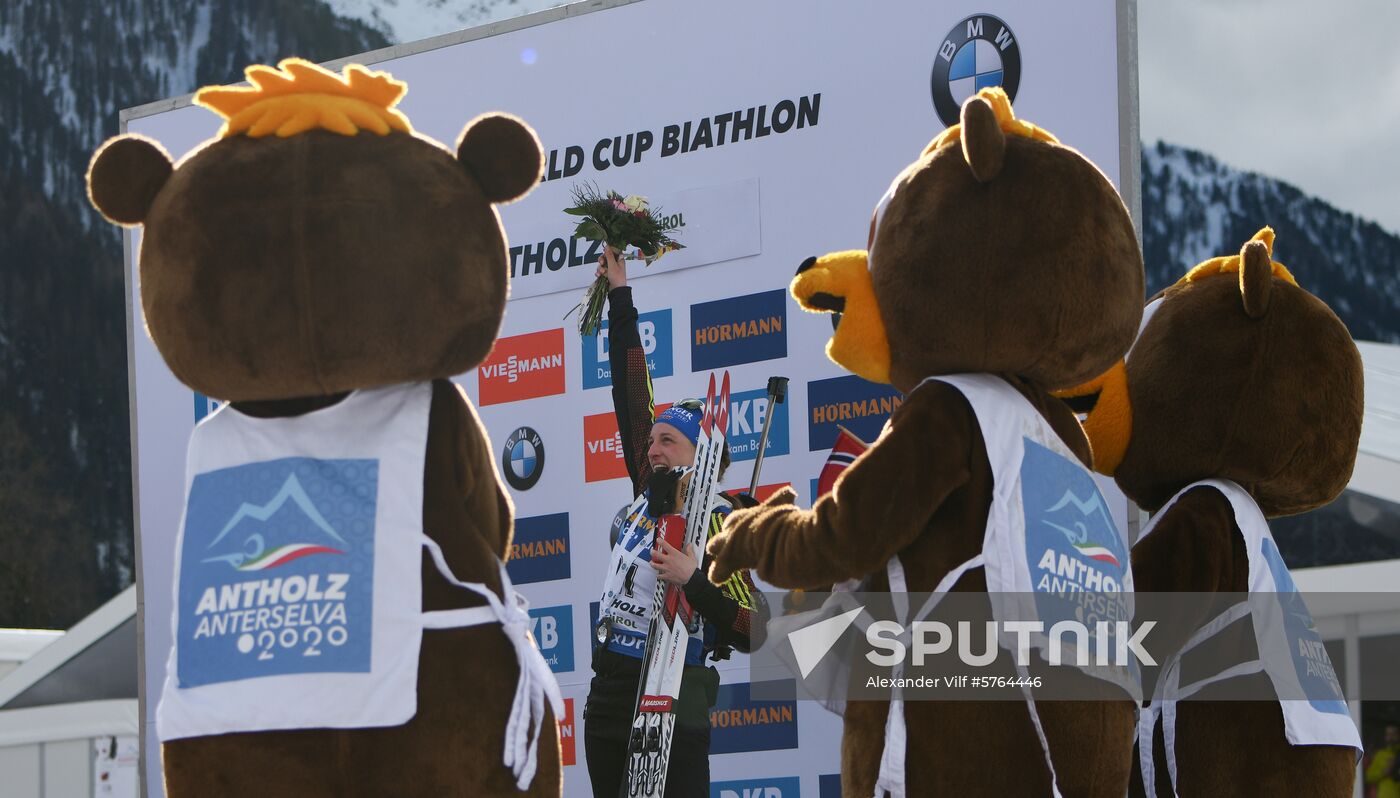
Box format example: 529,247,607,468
1138,0,1400,234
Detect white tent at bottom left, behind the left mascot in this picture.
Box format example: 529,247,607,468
0,587,140,798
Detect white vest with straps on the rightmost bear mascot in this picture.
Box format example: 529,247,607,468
1138,479,1361,798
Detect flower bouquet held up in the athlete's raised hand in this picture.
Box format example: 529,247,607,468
564,183,685,336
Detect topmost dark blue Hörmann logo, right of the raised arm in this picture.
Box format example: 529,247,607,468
690,288,787,371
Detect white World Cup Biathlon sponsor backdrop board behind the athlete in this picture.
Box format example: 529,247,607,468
123,0,1137,798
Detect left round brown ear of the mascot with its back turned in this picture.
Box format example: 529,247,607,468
87,134,174,227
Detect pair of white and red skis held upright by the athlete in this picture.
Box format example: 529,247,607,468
622,371,729,798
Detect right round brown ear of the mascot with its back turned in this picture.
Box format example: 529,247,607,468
456,113,545,203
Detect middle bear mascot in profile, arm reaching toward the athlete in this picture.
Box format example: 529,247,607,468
708,90,1142,798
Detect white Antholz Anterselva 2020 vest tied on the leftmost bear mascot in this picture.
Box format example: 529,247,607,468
157,382,563,790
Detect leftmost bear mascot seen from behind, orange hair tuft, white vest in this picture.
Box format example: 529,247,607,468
88,59,560,798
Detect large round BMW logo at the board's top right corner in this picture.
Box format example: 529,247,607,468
932,14,1021,126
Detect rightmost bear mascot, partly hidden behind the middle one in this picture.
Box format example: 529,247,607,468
1067,228,1364,798
